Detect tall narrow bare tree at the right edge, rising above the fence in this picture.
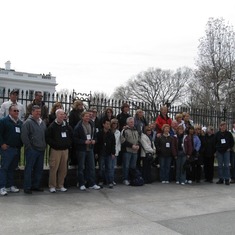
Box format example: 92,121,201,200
195,18,235,111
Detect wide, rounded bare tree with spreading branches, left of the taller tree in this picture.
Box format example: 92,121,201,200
113,67,193,111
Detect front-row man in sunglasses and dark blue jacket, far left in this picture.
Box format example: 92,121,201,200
0,105,23,196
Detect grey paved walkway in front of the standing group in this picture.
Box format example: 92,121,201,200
0,183,235,235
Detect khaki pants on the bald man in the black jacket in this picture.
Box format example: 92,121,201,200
49,148,68,188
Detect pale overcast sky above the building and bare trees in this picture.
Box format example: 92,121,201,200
0,0,235,94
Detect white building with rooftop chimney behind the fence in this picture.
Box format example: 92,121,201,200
0,61,57,97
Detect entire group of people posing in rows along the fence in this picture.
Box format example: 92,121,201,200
0,90,235,196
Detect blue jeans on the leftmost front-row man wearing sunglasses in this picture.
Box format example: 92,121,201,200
0,147,20,188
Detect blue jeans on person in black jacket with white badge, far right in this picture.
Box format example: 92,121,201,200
216,151,230,180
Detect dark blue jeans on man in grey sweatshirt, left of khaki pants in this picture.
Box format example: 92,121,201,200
24,149,44,189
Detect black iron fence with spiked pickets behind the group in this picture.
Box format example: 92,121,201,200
0,89,235,165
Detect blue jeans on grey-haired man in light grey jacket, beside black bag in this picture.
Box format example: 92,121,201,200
122,152,137,180
